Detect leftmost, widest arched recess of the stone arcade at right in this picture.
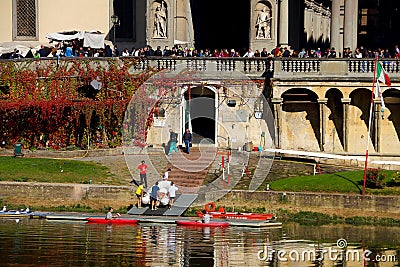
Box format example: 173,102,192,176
281,88,321,151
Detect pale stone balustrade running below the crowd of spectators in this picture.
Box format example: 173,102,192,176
0,57,400,81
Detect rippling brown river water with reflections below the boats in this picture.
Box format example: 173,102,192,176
0,219,400,267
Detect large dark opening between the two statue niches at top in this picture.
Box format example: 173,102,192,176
190,0,250,51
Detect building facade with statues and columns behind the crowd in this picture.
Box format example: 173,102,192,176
0,0,400,52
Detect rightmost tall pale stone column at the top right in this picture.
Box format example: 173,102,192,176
343,0,358,51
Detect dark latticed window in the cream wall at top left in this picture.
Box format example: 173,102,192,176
13,0,38,40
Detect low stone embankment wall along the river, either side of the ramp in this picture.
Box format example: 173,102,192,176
0,182,400,217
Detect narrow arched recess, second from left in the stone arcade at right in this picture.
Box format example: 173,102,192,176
325,88,344,151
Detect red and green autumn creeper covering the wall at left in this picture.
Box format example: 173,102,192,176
0,59,152,149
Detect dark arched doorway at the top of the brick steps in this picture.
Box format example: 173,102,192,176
182,86,217,144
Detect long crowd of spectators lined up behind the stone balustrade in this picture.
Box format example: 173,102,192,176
3,40,400,59
